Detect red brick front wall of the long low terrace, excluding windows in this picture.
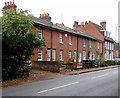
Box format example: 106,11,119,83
32,23,102,61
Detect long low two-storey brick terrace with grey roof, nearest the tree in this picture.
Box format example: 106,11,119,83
32,13,102,63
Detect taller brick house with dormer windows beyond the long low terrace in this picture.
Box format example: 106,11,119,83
73,21,115,60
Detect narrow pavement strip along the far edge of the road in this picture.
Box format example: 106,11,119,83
65,65,120,75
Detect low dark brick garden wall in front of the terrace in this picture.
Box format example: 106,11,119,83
32,61,61,73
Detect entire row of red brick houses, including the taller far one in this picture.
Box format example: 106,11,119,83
3,2,115,63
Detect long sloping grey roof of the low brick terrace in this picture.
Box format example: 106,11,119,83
33,17,101,41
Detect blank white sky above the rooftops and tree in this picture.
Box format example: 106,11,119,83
0,0,120,42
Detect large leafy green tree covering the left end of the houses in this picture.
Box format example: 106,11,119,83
1,10,44,80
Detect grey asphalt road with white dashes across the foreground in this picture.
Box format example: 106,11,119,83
2,68,118,96
